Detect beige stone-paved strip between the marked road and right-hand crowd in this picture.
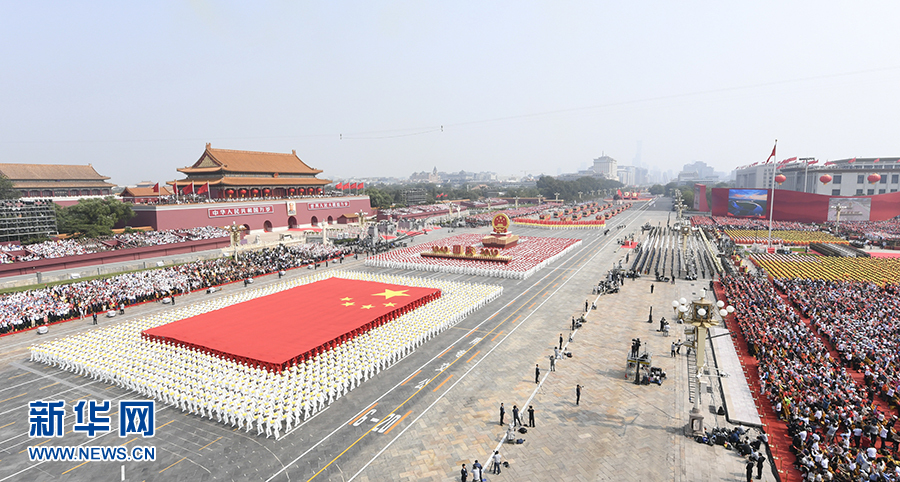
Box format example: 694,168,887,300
356,218,775,482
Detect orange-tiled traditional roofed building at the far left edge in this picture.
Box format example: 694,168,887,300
0,164,116,199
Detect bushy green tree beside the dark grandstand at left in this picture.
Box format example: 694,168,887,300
56,197,134,238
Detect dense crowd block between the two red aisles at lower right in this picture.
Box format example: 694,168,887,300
721,275,900,481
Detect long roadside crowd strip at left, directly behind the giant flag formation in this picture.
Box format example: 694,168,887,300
0,243,350,334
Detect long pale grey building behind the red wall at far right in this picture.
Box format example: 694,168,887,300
735,157,900,196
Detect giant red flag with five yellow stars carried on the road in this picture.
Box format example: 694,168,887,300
143,278,441,371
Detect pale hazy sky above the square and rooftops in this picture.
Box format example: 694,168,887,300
0,0,900,185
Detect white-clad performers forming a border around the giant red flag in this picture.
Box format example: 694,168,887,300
31,272,502,438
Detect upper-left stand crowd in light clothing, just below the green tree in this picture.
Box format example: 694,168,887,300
0,226,228,263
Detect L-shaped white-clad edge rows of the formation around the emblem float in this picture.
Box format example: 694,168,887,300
365,240,581,279
